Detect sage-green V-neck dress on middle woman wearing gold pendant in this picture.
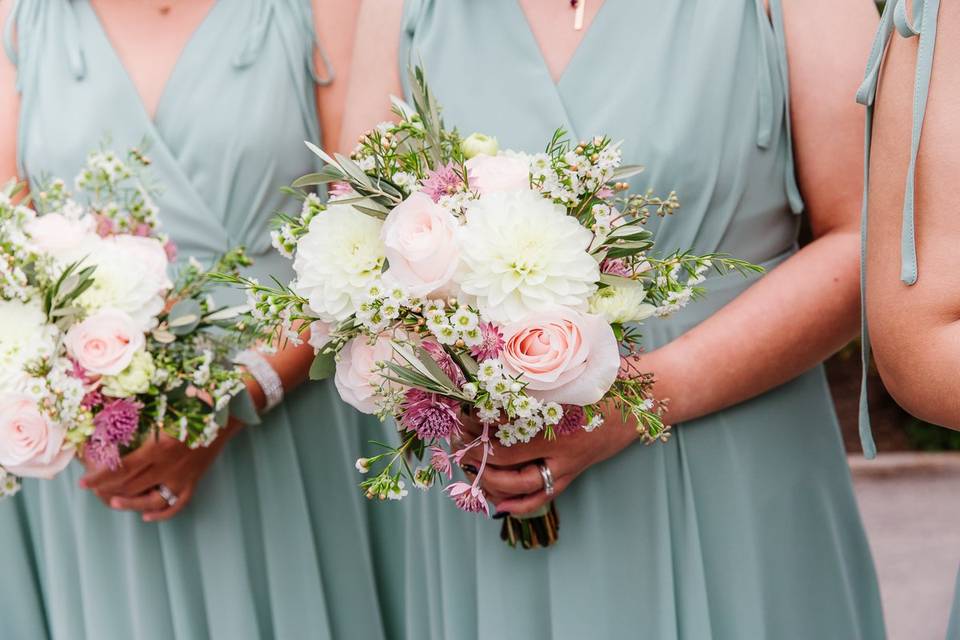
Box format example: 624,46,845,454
400,0,885,640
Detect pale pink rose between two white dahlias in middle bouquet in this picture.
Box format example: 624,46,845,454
380,192,460,296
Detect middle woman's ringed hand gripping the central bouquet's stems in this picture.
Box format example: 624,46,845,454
461,411,638,515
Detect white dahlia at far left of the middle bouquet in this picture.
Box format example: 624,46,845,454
293,204,384,322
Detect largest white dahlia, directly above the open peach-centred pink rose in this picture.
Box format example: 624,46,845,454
458,191,600,322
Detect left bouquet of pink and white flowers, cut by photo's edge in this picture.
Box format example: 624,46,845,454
0,149,256,496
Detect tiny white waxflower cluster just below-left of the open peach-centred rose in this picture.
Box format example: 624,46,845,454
477,358,563,447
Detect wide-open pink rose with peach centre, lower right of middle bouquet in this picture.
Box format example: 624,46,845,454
500,308,620,405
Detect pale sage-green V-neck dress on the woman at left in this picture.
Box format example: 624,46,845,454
0,0,400,640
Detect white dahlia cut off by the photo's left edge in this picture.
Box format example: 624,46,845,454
0,300,57,392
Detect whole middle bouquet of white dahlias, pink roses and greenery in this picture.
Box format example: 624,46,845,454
226,70,757,547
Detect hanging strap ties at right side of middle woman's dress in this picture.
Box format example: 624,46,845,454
755,0,803,214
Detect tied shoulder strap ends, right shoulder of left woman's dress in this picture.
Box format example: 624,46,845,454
234,0,335,86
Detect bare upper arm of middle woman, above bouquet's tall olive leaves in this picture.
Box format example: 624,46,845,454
340,0,403,151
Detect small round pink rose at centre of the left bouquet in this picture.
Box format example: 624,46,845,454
64,309,145,376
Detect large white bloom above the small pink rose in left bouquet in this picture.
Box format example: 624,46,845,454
78,235,173,330
